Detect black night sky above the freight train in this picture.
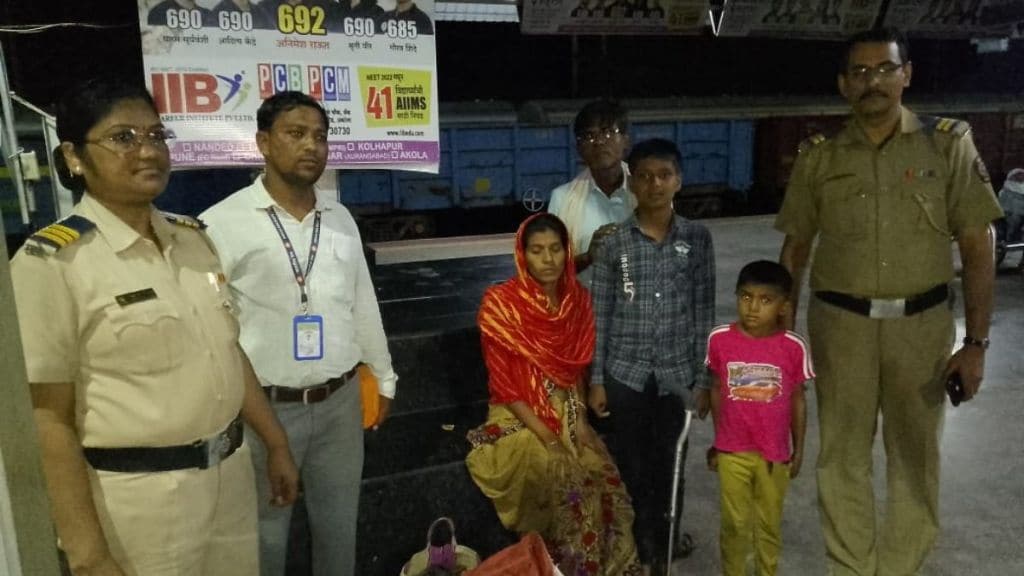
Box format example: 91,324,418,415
0,0,1024,107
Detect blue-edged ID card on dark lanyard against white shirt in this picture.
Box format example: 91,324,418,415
266,206,324,361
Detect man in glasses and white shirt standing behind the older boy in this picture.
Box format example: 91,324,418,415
548,99,637,289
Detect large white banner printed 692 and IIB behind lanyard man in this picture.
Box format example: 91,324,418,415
138,0,440,172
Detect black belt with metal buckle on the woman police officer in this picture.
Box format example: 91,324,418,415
82,418,243,472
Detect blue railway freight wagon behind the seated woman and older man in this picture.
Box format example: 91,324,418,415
339,115,754,240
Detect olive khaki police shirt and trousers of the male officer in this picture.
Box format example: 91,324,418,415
775,109,1000,576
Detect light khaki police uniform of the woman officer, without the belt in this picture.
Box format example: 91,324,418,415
11,195,258,576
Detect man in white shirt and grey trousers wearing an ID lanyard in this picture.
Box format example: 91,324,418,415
201,92,397,576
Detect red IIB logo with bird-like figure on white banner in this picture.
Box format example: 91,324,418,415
150,72,251,114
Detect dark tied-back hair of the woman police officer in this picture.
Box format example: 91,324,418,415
53,78,159,193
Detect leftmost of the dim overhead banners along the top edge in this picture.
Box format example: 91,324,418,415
520,0,709,36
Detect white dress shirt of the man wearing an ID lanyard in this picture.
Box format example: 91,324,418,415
200,177,397,398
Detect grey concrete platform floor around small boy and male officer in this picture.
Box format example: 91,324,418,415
675,217,1024,576
